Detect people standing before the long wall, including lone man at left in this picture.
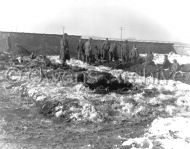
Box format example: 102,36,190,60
60,34,139,63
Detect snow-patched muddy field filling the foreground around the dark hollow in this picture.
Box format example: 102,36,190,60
0,54,190,149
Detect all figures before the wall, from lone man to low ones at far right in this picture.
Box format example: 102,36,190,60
60,33,180,77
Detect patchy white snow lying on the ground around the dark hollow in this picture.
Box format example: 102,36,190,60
4,53,190,149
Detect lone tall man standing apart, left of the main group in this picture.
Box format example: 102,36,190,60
60,33,70,64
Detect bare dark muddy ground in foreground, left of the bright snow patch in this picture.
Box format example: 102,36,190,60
0,75,151,149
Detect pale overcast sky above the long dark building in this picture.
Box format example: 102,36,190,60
0,0,190,43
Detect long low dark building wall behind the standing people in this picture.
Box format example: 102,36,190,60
0,31,178,57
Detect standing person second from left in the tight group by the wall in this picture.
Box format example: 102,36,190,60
84,38,92,63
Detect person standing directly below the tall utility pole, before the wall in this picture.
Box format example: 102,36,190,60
121,40,130,63
